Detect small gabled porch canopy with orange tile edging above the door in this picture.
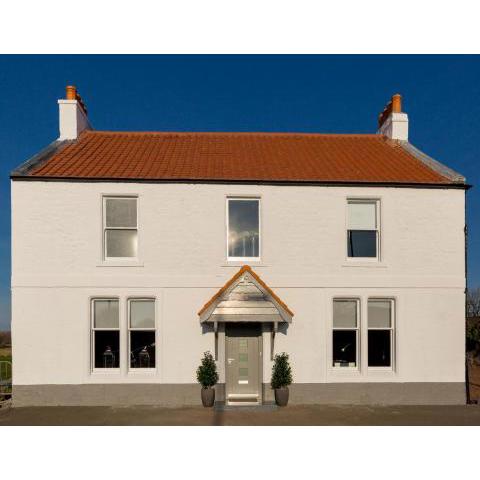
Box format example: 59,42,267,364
198,265,293,331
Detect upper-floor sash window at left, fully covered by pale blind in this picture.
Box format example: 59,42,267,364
103,197,138,260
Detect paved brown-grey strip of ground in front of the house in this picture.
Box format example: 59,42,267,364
0,405,480,426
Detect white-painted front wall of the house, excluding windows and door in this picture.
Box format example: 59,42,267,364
12,181,465,385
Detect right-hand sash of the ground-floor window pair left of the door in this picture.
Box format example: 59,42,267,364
128,298,156,369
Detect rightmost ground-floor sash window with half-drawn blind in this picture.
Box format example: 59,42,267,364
368,298,394,367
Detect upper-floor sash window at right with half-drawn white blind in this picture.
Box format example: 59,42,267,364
347,200,380,258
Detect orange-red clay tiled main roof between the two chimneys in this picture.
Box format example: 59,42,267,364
12,130,465,185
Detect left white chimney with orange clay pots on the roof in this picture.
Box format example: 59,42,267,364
58,85,92,140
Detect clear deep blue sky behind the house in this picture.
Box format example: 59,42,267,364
0,55,480,329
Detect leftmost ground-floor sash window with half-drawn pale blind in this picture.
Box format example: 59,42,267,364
92,298,120,369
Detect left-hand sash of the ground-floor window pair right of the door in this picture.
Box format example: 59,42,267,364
332,299,359,367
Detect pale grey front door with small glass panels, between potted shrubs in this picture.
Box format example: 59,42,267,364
225,323,262,405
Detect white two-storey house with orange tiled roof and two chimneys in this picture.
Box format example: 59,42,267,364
11,87,468,405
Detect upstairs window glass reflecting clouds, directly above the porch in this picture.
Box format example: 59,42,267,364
228,200,259,257
